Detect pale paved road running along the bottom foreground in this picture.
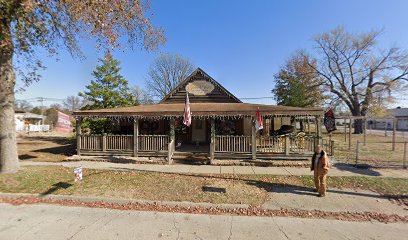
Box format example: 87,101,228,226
0,203,408,240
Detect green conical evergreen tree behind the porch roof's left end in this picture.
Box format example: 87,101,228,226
79,51,138,110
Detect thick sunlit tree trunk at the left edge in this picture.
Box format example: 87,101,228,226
0,19,19,173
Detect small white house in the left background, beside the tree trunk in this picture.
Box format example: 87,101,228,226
14,111,50,132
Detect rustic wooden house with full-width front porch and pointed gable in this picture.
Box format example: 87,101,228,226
73,68,332,163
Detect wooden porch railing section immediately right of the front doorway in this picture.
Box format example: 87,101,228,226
215,135,251,153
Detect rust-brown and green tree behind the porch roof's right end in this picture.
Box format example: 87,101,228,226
272,52,325,107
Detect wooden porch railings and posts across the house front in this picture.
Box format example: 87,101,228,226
77,119,334,164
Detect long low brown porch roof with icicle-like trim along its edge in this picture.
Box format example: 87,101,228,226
73,103,324,119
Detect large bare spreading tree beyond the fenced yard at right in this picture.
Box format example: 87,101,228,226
310,27,408,133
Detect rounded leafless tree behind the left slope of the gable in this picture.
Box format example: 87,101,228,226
146,53,194,98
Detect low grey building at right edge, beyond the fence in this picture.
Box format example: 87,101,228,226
367,107,408,131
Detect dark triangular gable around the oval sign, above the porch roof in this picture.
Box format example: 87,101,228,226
160,68,242,103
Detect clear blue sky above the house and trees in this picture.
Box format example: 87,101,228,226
16,0,408,107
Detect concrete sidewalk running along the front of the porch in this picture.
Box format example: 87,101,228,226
21,161,408,178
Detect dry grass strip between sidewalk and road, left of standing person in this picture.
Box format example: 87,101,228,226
0,166,267,206
